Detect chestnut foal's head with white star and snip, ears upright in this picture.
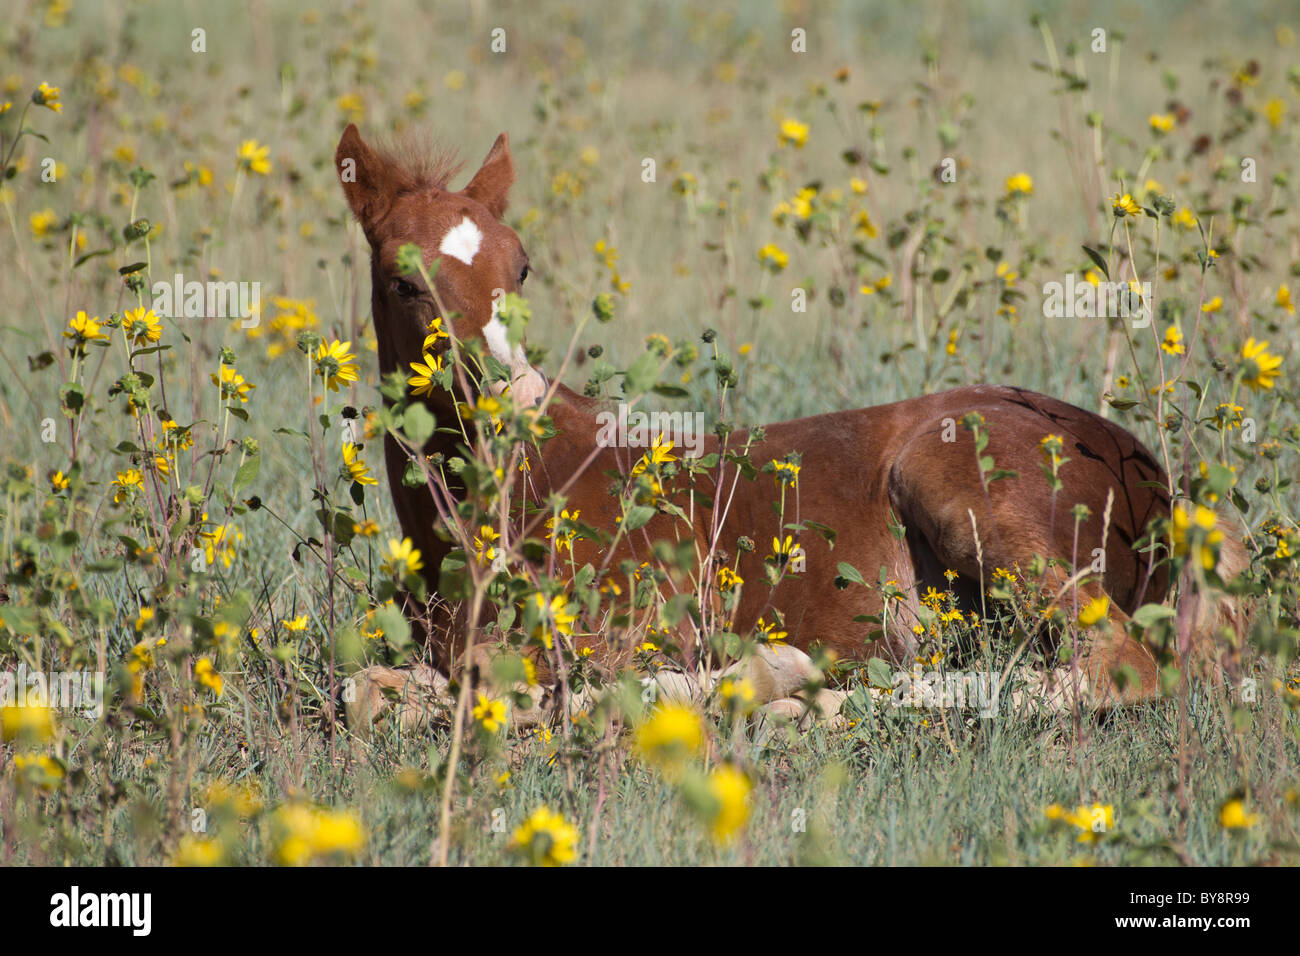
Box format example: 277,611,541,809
334,124,546,405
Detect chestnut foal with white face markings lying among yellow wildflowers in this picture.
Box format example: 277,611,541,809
335,125,1244,733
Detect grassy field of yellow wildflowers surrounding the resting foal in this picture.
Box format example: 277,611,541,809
0,0,1300,866
